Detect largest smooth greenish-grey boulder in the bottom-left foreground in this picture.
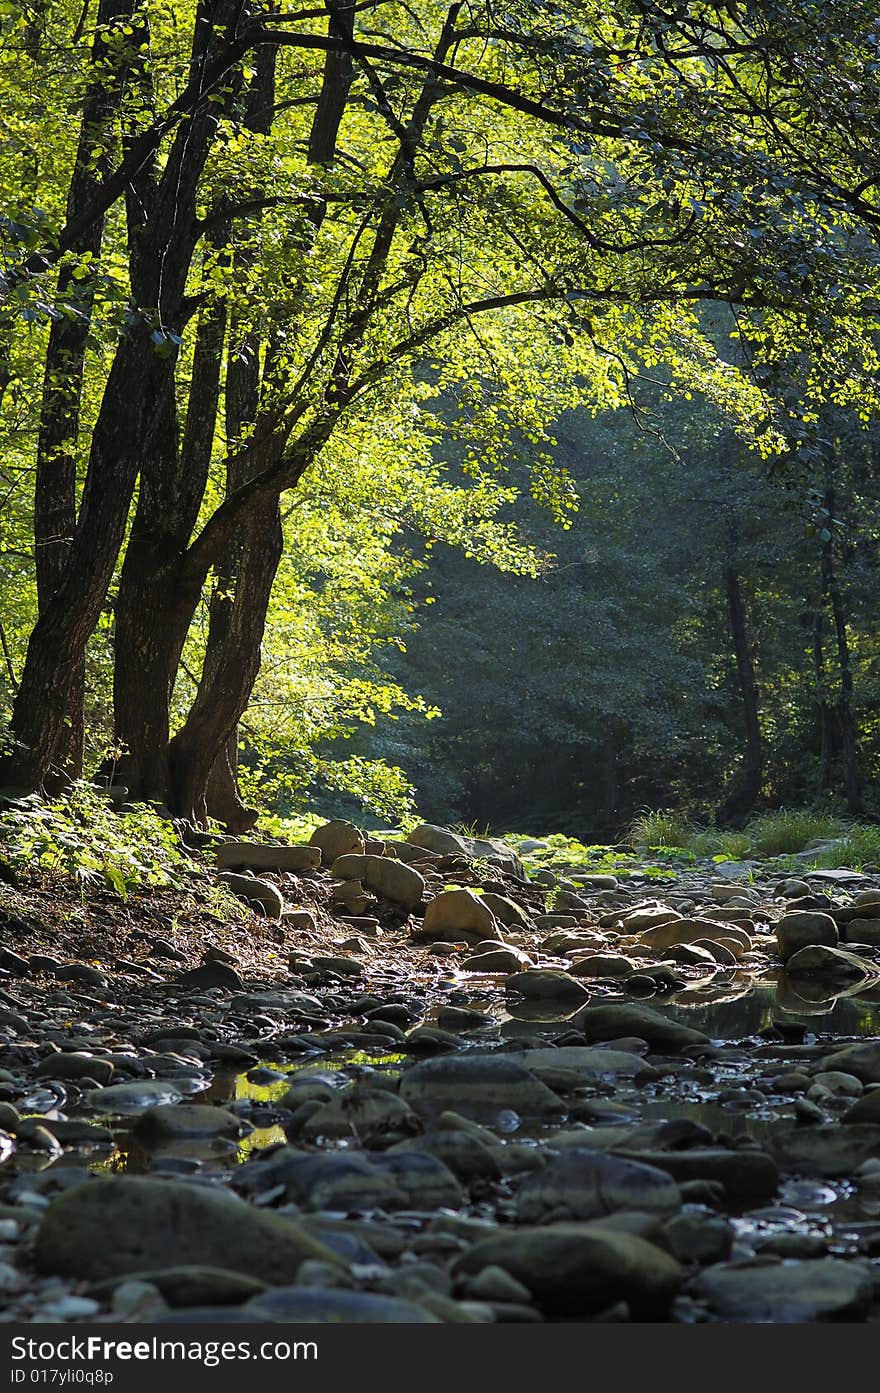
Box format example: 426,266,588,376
35,1176,338,1284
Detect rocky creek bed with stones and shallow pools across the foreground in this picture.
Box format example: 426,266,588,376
0,834,880,1323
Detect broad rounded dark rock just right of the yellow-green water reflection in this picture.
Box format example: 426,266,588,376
400,1053,564,1119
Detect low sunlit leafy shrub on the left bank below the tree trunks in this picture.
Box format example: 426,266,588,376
0,780,191,897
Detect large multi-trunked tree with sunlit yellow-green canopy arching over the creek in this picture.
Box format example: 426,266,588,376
3,0,877,819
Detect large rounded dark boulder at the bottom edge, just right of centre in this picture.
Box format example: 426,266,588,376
454,1223,681,1319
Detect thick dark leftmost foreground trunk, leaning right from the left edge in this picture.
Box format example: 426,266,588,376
0,0,238,787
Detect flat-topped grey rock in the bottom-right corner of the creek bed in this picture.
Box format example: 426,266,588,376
691,1258,873,1325
